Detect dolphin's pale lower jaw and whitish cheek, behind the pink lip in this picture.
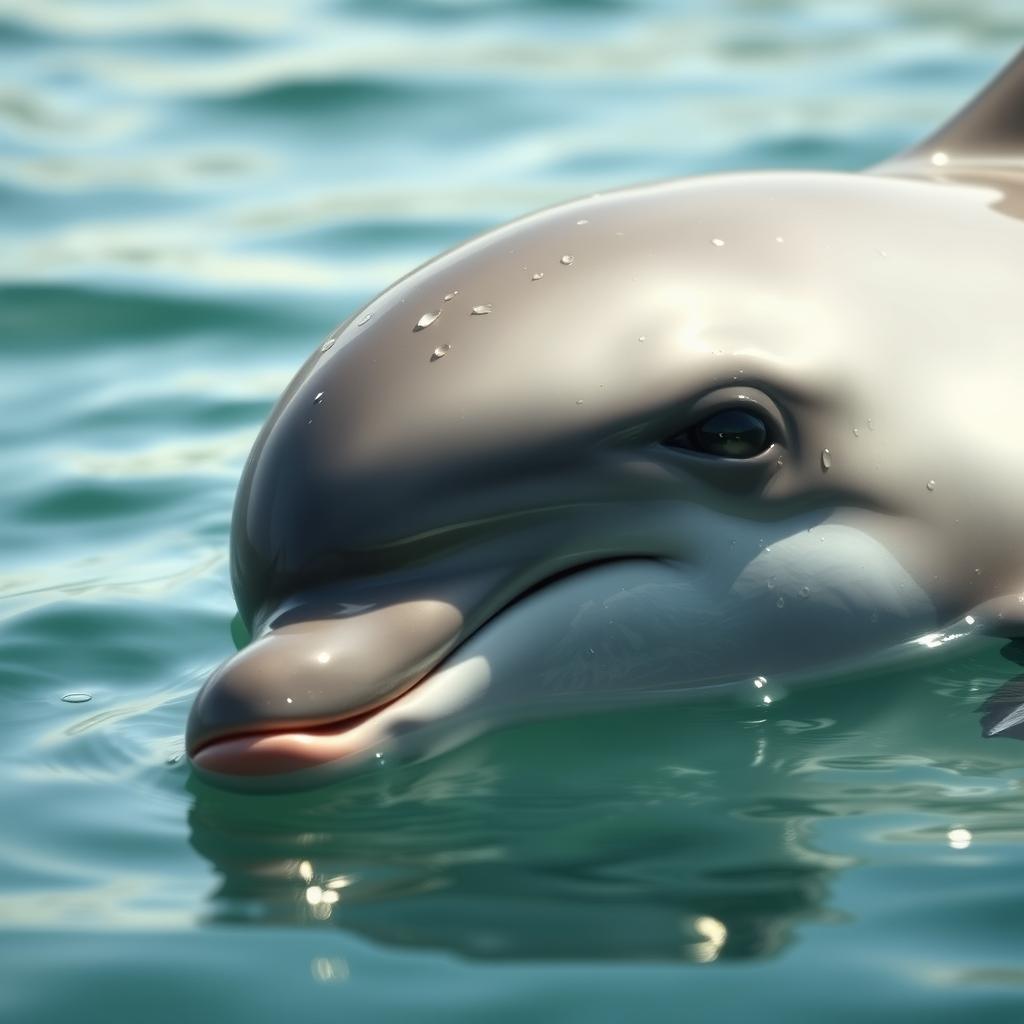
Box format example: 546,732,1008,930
329,523,938,761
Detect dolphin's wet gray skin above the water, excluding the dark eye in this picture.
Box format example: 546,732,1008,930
187,48,1024,783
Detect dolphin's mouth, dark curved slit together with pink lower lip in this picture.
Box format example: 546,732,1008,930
187,554,660,777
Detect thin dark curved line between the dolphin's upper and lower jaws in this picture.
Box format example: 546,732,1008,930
188,554,660,774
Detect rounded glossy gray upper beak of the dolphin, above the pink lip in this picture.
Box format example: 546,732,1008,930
185,599,463,760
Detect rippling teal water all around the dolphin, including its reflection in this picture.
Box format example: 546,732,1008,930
0,0,1024,1024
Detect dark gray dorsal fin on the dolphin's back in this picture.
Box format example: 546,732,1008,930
871,49,1024,174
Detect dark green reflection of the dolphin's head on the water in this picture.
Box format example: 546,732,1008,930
191,703,845,963
